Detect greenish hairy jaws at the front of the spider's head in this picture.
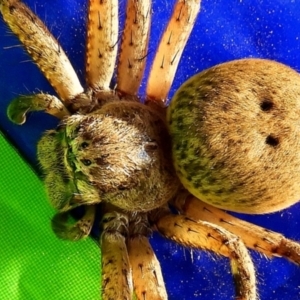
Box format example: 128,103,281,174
38,126,100,211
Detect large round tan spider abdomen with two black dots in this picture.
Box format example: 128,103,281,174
168,59,300,214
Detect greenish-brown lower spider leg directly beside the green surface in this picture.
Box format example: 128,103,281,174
100,210,133,300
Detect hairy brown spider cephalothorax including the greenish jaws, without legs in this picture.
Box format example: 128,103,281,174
38,101,180,211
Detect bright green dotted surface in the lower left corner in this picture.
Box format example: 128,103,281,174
0,134,100,300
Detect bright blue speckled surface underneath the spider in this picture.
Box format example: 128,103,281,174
0,0,300,300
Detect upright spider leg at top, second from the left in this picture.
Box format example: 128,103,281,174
86,0,119,91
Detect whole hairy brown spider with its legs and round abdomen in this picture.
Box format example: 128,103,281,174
0,0,300,300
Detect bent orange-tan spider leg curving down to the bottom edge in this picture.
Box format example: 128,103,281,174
151,210,257,300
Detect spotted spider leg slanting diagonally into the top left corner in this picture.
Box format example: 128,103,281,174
0,0,83,102
